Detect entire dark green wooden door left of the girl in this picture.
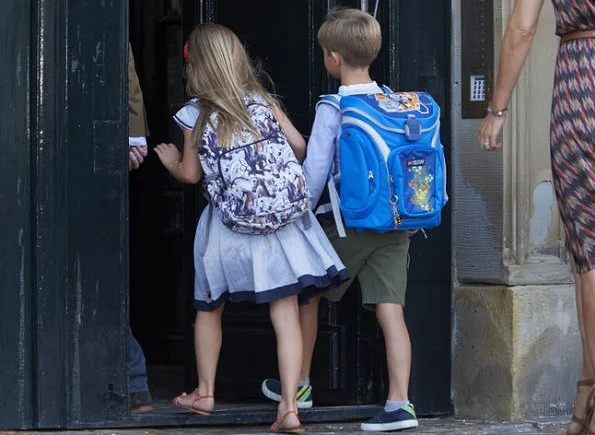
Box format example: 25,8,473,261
0,0,128,429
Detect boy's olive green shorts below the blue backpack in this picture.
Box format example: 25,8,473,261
321,221,409,310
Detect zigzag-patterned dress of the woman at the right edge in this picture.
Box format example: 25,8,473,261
551,0,595,273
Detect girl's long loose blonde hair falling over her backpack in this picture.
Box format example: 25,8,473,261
186,24,275,148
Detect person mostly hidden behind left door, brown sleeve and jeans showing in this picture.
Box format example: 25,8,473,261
128,43,153,413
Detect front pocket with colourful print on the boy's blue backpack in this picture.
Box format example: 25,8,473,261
388,145,444,218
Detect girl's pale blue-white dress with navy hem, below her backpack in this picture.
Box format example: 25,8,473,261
174,97,348,311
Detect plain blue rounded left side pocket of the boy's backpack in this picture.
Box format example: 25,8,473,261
340,129,386,219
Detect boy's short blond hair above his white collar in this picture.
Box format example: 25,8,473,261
318,9,382,68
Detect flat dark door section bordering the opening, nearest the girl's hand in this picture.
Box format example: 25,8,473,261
65,2,128,423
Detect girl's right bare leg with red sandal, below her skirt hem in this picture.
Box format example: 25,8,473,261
270,296,303,428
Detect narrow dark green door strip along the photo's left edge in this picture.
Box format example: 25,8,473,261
0,0,34,430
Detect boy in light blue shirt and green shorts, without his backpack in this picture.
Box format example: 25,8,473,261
262,9,418,431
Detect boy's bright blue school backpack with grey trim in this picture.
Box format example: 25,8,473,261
318,87,448,235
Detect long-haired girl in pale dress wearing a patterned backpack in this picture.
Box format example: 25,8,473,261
156,24,347,432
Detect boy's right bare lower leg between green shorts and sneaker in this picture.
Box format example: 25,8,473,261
376,304,411,401
